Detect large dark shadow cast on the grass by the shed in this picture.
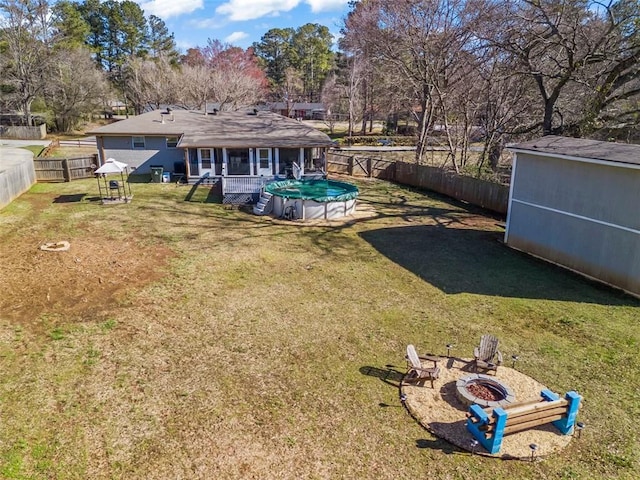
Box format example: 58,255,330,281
360,225,640,306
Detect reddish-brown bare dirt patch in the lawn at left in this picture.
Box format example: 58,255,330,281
0,237,172,324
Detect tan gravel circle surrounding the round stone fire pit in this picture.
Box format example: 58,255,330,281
401,357,572,459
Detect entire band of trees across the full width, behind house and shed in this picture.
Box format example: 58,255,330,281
0,0,640,171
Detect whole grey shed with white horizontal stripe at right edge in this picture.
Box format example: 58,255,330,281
505,136,640,295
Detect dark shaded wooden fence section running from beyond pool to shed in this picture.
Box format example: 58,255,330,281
396,162,509,214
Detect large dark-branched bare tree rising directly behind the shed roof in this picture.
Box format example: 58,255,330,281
480,0,640,135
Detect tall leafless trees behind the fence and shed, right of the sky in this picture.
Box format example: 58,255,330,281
338,0,640,170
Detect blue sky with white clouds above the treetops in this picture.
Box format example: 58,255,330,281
139,0,349,52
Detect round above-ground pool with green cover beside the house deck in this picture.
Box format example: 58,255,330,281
264,180,359,220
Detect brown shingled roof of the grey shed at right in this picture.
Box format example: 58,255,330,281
509,135,640,165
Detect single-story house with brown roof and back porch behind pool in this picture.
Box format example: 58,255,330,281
90,110,332,203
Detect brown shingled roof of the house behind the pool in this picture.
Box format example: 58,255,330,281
90,110,332,148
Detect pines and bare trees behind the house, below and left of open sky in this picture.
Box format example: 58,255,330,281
0,0,334,131
